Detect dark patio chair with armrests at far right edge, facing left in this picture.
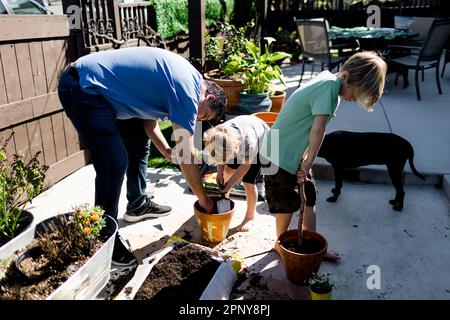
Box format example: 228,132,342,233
389,18,450,100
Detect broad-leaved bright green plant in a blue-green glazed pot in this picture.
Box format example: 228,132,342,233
224,37,290,114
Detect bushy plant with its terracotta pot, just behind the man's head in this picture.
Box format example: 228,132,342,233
204,20,255,111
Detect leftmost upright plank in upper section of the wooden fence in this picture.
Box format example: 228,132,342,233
0,44,22,103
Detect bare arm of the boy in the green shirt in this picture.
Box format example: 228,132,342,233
297,114,328,181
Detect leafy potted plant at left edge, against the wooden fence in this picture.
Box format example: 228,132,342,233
0,135,48,247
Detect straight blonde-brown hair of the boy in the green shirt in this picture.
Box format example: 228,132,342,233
340,51,387,111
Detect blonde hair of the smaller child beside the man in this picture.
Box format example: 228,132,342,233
203,124,241,165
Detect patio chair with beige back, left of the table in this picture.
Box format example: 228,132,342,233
294,19,356,86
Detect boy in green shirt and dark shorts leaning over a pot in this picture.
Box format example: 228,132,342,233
260,52,387,260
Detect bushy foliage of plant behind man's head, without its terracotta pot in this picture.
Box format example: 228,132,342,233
204,20,255,79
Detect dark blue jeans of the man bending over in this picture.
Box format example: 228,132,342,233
58,67,149,220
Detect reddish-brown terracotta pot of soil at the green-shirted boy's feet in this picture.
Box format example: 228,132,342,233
278,229,328,284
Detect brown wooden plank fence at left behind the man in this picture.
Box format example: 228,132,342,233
0,15,87,185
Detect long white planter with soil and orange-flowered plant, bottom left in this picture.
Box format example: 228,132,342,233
0,205,118,300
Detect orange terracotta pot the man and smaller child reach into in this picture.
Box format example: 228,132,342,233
194,197,234,242
